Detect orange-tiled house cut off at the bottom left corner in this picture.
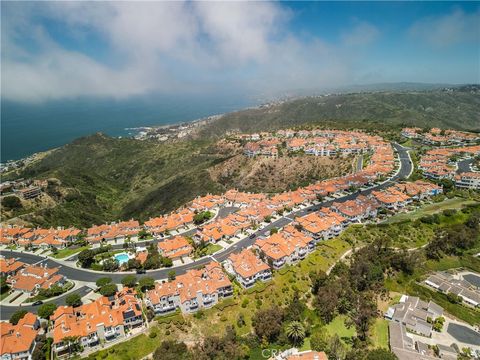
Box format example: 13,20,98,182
0,313,40,360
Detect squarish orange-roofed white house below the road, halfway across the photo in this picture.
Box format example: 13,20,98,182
224,249,272,288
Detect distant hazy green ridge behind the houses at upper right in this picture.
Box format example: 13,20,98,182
200,85,480,136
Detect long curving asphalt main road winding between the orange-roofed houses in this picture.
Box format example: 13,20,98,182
0,144,413,318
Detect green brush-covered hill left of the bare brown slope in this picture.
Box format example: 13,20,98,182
11,134,222,226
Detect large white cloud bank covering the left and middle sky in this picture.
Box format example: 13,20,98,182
1,2,378,101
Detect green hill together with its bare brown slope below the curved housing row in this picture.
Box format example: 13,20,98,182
2,134,353,226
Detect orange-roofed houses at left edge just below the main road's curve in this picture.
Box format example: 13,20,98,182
0,257,67,296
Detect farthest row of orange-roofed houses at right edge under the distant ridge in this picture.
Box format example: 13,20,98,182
402,127,480,146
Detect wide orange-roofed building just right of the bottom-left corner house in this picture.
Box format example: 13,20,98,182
50,288,143,356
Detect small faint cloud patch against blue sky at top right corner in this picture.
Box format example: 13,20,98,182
409,9,480,47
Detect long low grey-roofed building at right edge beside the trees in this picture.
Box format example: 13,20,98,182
424,272,480,307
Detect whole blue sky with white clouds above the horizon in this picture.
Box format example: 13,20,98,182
1,1,480,103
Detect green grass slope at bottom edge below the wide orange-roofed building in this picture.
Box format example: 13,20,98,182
87,334,162,360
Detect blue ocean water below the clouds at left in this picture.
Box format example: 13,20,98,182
1,95,258,162
